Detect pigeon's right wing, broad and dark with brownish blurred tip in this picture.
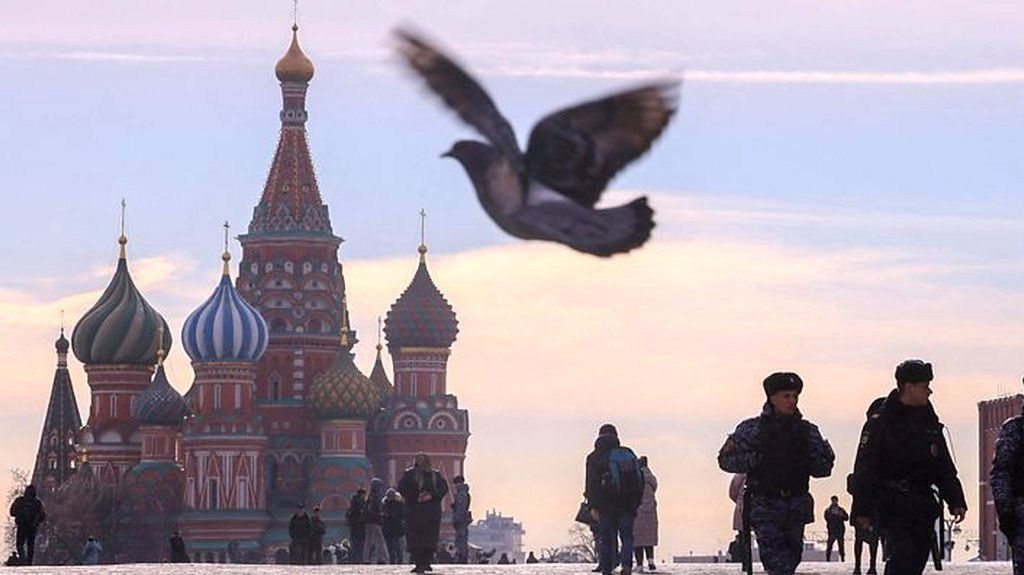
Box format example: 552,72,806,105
526,81,679,207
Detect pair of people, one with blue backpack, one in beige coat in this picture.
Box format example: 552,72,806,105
579,424,657,575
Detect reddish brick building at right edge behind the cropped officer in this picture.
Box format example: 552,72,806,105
978,394,1024,561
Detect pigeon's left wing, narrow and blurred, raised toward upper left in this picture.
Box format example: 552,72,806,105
394,30,523,170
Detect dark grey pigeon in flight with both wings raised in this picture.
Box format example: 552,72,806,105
395,30,679,257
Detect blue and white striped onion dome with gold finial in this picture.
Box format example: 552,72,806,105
181,251,267,363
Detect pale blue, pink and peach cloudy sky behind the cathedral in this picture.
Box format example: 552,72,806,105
0,0,1024,557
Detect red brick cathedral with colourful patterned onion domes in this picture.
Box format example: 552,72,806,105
32,26,469,563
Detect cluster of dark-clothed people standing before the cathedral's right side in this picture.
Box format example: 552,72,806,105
288,453,472,573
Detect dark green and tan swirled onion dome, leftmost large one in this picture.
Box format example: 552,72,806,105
71,234,171,365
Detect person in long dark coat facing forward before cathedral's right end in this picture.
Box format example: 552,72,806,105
398,453,449,573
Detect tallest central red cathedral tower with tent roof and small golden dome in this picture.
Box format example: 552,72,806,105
237,26,354,468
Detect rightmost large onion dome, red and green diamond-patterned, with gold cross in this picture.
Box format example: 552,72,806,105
384,245,459,349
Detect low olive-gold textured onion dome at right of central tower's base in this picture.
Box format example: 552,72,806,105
309,299,384,419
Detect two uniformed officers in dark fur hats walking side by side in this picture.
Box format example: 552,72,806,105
718,359,967,575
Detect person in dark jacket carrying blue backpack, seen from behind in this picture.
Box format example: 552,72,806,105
584,424,643,575
